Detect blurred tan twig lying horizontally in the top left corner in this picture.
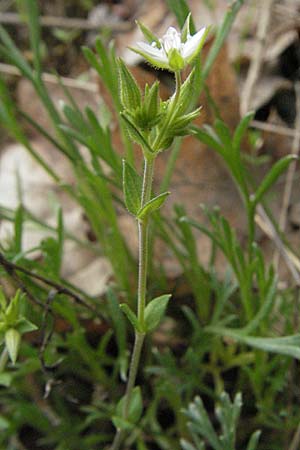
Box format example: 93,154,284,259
0,12,132,32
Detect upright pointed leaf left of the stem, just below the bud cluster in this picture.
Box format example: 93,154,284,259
123,159,142,216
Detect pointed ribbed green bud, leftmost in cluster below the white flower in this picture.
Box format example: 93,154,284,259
117,58,142,111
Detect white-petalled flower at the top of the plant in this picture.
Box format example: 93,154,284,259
132,27,208,72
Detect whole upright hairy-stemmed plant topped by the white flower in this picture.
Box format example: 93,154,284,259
111,15,208,450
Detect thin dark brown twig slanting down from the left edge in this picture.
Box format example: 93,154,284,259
0,253,102,318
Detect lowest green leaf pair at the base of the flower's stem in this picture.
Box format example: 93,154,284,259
113,386,143,429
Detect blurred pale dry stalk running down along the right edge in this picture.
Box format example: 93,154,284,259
274,81,300,268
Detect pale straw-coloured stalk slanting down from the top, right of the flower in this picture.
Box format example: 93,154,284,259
241,0,273,116
